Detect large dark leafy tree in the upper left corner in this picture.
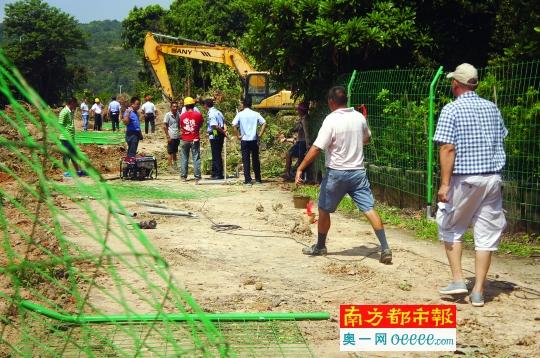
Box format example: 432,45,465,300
4,0,86,104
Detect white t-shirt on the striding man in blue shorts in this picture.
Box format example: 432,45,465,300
313,108,371,170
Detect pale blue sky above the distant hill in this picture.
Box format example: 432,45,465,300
0,0,173,23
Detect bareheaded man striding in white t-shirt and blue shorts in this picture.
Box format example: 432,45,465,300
295,86,392,265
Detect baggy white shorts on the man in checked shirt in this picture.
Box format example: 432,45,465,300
436,174,506,251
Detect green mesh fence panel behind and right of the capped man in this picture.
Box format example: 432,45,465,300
433,61,540,232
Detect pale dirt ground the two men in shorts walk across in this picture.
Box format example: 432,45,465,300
59,124,540,357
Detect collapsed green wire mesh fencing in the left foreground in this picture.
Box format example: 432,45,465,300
0,53,322,357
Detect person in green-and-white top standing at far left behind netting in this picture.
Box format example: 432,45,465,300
58,98,86,177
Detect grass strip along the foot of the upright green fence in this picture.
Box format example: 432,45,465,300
295,186,540,256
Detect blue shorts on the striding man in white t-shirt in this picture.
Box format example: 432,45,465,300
319,168,375,213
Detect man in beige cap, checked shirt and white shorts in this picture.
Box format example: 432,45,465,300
433,63,508,307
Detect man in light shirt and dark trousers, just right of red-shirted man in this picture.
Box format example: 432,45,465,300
204,98,227,179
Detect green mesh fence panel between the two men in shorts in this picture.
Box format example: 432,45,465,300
348,69,436,207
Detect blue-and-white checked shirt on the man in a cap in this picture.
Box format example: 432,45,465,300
433,91,508,174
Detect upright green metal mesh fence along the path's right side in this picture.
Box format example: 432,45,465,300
344,61,540,231
